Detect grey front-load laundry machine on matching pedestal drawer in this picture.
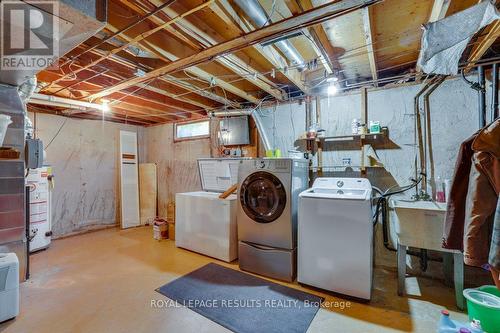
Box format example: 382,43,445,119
237,158,308,281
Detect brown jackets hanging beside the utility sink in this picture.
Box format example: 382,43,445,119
443,120,500,266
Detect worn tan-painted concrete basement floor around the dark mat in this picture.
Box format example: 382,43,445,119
0,227,466,333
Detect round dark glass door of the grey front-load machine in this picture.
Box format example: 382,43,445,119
240,171,286,223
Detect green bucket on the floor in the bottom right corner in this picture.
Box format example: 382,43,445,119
464,286,500,333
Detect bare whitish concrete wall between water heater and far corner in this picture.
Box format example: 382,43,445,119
29,114,144,237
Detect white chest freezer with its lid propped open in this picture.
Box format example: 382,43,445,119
175,159,246,262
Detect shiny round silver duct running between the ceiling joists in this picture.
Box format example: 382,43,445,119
234,0,305,69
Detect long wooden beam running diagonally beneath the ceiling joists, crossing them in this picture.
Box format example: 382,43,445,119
91,0,380,98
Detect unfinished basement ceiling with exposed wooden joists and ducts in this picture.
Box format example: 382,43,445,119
30,0,497,126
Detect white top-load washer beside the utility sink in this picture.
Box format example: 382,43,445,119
297,178,373,300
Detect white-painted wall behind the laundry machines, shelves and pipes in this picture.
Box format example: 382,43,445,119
262,79,480,191
